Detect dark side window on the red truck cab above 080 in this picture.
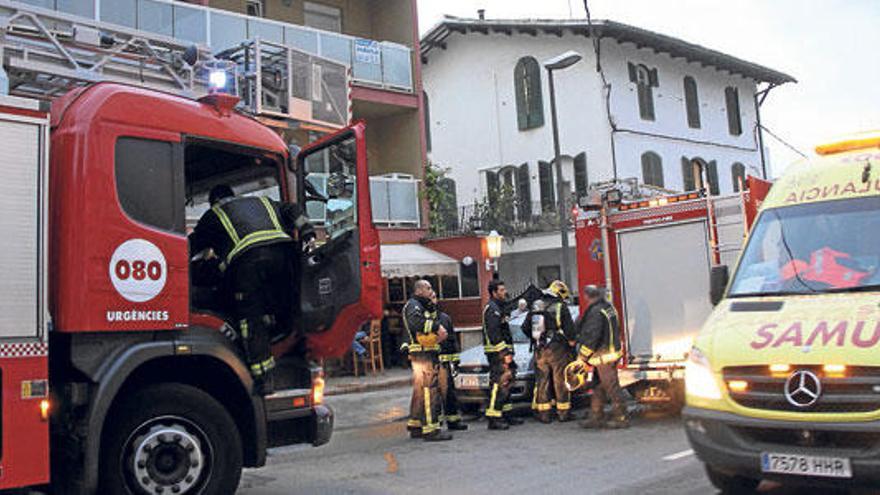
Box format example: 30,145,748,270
115,137,186,234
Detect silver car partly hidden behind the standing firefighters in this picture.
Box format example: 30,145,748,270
455,306,579,412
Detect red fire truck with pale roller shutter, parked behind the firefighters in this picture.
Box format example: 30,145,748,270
575,177,769,410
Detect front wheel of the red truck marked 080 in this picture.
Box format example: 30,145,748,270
98,383,242,495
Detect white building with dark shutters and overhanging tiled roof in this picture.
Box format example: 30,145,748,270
421,17,794,287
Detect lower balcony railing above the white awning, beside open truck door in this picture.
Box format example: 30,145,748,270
370,174,421,228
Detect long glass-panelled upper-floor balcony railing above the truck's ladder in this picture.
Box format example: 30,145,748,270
19,0,413,92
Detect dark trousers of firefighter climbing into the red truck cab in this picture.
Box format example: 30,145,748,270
226,244,295,378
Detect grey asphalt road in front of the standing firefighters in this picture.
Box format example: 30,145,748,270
239,389,872,495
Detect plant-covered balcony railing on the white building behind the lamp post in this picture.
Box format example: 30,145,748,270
430,201,576,237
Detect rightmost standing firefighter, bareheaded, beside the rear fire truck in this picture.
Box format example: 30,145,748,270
577,285,629,428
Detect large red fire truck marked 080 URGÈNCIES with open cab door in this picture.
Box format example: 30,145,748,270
0,83,381,494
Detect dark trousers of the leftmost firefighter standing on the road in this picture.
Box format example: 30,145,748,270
407,352,443,435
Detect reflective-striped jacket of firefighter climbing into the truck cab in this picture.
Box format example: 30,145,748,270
189,197,314,270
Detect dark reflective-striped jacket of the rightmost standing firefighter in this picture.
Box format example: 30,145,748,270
575,299,622,366
